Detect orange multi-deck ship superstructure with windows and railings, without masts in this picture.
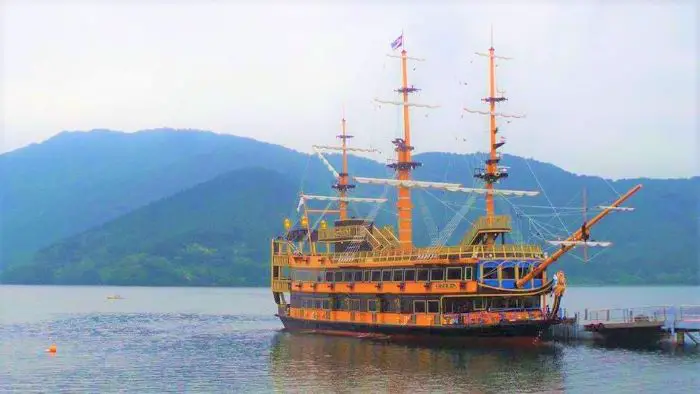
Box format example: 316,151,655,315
272,216,553,325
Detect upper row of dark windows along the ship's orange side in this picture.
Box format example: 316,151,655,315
291,267,474,283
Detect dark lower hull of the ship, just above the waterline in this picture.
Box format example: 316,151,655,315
278,316,556,338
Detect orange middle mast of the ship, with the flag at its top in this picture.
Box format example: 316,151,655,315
389,49,420,249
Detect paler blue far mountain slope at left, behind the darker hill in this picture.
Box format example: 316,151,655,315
0,129,326,268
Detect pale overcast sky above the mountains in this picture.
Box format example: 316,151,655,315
0,0,700,179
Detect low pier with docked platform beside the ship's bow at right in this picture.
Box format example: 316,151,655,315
550,305,700,346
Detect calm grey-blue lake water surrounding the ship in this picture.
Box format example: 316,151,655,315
0,286,700,393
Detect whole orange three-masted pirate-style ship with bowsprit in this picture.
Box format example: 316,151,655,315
271,35,641,337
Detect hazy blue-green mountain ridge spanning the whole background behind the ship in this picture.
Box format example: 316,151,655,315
0,129,700,285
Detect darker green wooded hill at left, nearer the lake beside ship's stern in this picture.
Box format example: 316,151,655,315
3,168,296,286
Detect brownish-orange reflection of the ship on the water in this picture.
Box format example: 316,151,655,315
270,332,564,393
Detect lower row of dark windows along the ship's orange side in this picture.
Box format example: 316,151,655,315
292,296,540,313
